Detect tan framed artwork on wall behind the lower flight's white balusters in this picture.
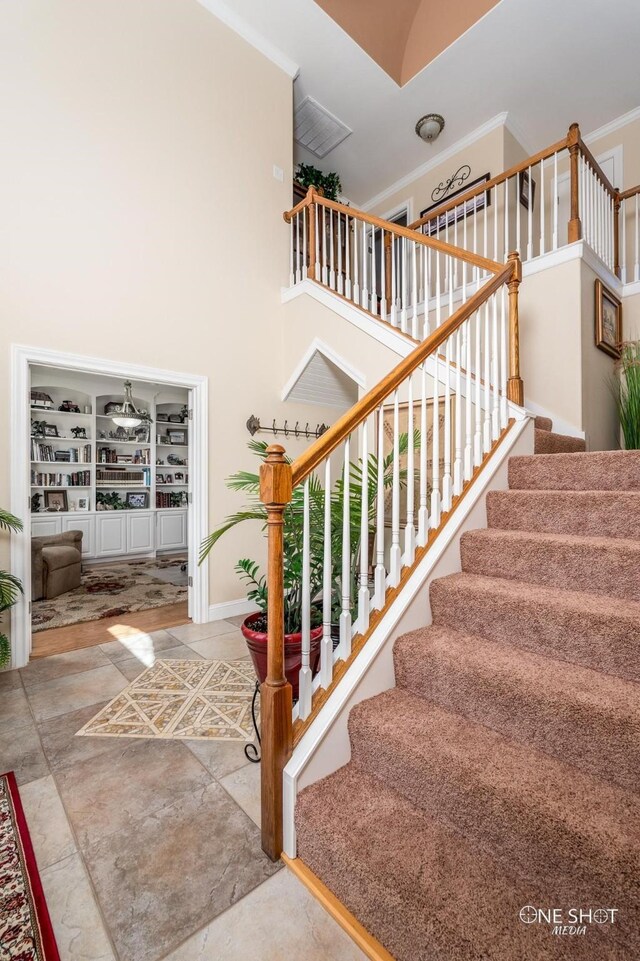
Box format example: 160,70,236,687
376,396,455,527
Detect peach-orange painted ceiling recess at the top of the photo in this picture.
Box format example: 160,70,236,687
316,0,499,86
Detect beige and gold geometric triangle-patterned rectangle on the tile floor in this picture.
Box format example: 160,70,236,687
78,657,256,741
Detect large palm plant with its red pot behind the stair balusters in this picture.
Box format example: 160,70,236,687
200,431,420,699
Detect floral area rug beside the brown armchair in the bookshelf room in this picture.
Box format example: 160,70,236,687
31,557,188,631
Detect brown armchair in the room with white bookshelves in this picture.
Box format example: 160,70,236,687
31,531,82,601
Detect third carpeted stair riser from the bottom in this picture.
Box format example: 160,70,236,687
394,646,640,794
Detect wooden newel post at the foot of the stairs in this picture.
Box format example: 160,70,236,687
260,444,293,861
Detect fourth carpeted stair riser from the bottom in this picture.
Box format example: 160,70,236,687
430,579,640,681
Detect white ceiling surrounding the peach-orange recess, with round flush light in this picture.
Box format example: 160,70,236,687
200,0,640,205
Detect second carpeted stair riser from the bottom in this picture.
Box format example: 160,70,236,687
349,712,640,928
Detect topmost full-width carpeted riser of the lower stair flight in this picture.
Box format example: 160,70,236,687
509,450,640,491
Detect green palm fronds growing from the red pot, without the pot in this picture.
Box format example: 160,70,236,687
200,430,420,634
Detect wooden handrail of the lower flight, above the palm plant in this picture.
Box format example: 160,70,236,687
292,254,521,487
